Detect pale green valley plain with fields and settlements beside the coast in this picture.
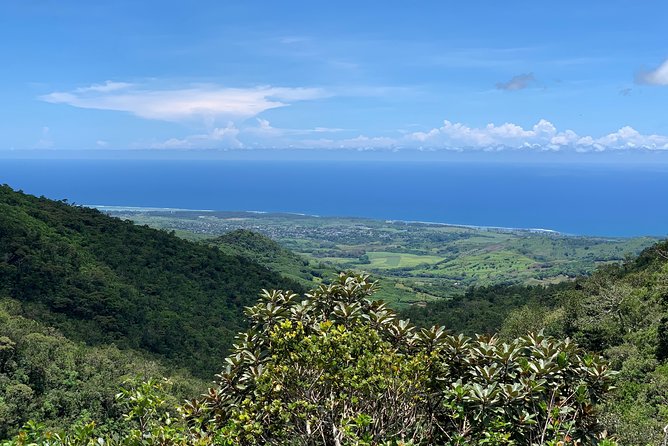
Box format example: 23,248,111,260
98,207,658,308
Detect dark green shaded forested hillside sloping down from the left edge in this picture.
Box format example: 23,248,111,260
0,186,301,378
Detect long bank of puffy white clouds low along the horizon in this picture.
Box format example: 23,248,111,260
149,118,668,152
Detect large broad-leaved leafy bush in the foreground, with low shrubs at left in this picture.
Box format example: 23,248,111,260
7,275,612,445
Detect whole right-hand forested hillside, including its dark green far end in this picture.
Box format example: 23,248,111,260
404,242,668,445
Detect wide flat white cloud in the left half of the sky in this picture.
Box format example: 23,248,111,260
40,81,327,122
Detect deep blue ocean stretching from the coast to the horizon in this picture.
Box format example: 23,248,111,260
0,159,668,236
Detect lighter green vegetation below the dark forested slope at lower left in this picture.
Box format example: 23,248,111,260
0,300,206,439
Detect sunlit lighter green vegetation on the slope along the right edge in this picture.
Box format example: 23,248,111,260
503,243,668,445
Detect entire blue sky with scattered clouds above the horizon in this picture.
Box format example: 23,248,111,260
0,0,668,153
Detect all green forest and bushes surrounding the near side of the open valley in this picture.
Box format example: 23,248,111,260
0,186,668,446
